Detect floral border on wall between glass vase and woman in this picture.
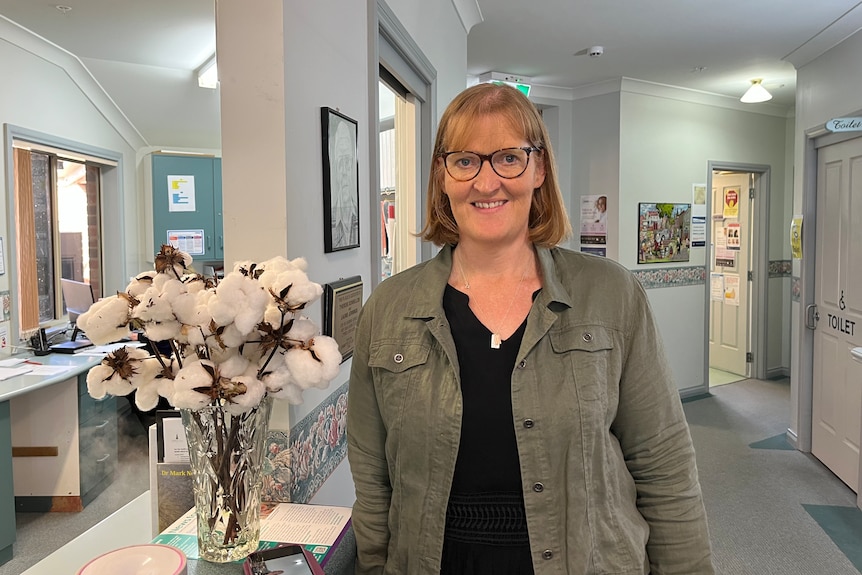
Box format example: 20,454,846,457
261,383,348,503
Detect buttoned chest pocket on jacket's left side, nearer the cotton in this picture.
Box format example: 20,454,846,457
368,341,431,419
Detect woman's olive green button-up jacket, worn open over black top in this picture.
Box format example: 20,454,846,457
347,246,713,575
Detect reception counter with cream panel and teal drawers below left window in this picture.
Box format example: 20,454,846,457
0,354,107,564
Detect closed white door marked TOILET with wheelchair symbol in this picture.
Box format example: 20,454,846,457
803,138,862,493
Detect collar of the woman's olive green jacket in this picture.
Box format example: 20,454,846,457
405,245,572,318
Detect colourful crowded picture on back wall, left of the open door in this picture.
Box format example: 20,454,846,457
638,203,691,264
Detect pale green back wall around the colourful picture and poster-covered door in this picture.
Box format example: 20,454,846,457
570,79,789,390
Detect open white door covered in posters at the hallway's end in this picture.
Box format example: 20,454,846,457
709,171,753,377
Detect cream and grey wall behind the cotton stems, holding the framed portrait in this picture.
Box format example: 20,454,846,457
217,0,466,505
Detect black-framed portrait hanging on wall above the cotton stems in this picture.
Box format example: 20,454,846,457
320,107,359,253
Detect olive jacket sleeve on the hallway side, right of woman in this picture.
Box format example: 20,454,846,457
612,280,714,575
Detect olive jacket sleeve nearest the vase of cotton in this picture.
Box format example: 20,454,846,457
347,303,392,575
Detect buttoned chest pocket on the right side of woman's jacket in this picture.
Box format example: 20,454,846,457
550,325,616,403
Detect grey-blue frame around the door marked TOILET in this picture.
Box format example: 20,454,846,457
804,115,862,509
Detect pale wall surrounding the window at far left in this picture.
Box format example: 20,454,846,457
0,18,145,351
